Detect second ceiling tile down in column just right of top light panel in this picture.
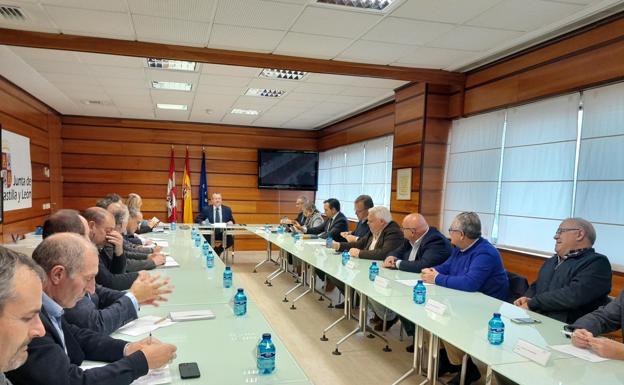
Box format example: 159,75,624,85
362,17,454,45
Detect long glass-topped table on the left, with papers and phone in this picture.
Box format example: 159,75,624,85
113,230,311,385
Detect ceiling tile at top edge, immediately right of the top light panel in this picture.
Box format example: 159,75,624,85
392,0,501,23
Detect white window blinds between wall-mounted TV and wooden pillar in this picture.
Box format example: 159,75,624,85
316,136,393,219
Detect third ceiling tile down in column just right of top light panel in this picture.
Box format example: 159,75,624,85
336,40,416,64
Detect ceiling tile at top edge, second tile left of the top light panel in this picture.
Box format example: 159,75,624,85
128,0,216,23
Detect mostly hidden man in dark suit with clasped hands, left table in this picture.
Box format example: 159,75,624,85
43,209,171,334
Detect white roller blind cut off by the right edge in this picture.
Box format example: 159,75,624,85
574,84,624,270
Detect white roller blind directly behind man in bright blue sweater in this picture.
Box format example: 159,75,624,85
443,111,505,237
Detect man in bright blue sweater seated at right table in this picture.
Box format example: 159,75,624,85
421,212,509,384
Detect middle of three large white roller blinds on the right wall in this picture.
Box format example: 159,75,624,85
498,93,580,251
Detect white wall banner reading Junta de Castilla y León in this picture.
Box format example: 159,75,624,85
2,130,32,211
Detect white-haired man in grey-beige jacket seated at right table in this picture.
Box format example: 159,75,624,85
333,206,403,261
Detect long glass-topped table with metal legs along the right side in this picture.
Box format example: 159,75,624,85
240,226,624,385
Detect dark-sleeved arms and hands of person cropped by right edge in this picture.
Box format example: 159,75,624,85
572,290,624,360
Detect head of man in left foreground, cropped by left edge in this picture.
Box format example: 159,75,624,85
0,246,45,385
